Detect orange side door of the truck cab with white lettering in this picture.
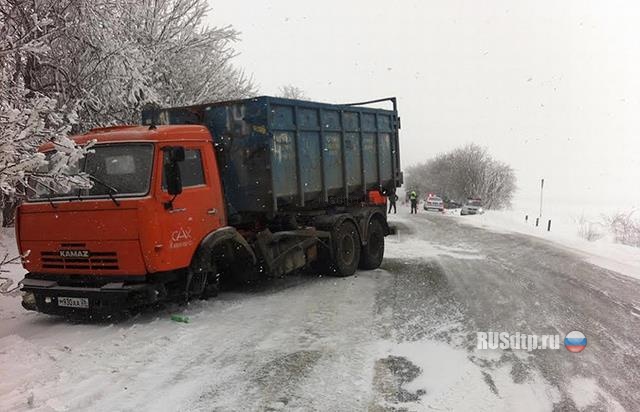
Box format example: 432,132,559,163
159,142,225,269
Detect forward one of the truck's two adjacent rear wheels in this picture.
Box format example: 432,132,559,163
331,220,361,277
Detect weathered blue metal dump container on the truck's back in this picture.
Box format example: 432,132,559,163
142,96,402,222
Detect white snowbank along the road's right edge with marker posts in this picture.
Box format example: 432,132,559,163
449,210,640,279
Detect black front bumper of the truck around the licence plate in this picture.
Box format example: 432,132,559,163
20,275,164,315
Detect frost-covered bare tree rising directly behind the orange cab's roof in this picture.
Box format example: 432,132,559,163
47,0,254,125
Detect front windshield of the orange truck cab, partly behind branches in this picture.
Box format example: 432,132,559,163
29,143,153,200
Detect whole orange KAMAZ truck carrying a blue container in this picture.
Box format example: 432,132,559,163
16,97,402,315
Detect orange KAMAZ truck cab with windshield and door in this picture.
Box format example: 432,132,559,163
16,125,238,316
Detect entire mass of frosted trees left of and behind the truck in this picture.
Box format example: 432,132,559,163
0,0,254,224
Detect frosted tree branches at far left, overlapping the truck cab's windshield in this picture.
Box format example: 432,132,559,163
0,0,95,221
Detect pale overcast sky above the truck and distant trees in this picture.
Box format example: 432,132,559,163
210,0,640,209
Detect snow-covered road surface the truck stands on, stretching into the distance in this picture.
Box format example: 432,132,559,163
0,210,640,411
